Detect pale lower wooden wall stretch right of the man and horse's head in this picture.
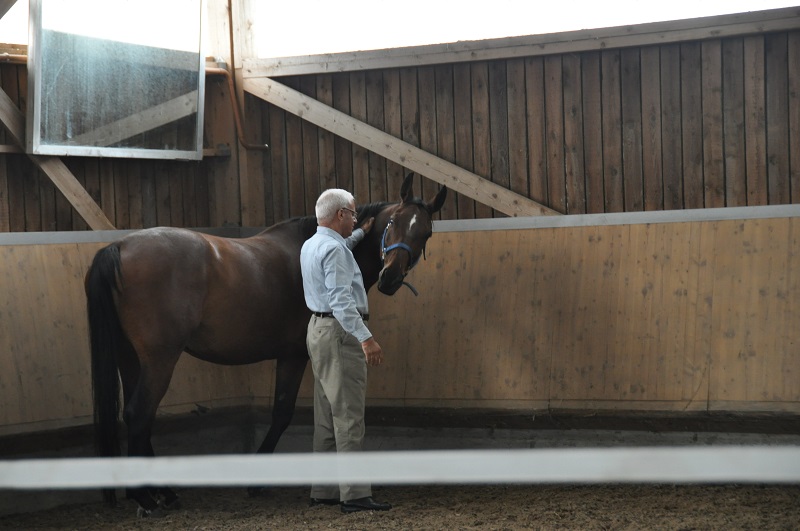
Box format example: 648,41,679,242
366,214,800,413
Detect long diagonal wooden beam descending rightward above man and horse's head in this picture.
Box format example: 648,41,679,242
244,78,559,216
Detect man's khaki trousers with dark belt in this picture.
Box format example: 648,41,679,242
306,316,372,501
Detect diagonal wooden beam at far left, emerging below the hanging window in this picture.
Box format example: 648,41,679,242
0,89,115,230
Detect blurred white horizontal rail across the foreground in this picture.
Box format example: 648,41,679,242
0,446,800,489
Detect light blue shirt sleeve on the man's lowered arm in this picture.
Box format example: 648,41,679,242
322,244,372,342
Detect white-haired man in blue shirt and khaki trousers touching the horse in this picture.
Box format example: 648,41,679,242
300,189,392,513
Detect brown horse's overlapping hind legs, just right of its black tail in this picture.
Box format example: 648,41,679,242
120,351,180,516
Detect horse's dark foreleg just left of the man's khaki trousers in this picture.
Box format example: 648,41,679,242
247,351,308,496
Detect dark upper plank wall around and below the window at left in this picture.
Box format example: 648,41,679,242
0,63,242,232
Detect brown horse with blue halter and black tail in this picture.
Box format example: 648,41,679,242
84,174,447,516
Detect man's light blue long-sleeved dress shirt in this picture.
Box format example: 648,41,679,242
300,227,372,342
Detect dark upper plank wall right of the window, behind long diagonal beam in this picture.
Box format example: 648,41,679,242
255,31,800,219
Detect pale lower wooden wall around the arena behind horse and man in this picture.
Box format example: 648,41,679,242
0,209,800,434
